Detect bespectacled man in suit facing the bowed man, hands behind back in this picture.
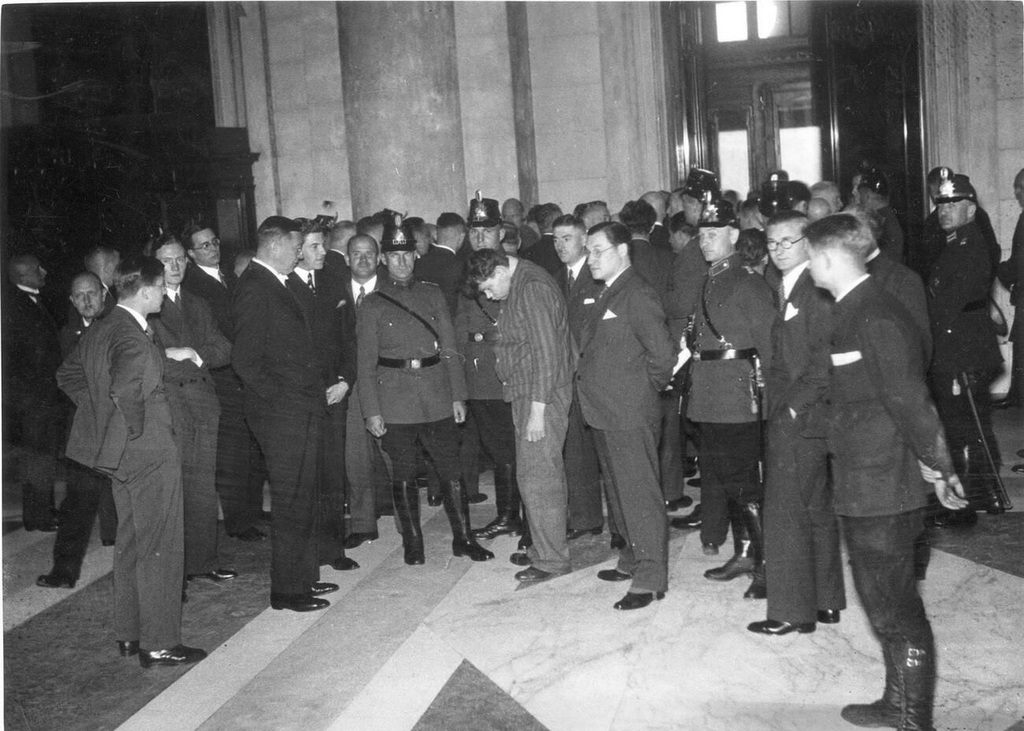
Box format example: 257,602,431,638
577,223,675,609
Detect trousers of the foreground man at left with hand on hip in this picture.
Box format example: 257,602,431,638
112,436,184,650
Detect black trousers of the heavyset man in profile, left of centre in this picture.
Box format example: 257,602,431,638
247,397,325,595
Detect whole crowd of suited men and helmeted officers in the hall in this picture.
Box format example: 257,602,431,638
4,160,1024,729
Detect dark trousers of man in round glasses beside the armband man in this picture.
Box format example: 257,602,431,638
764,415,846,625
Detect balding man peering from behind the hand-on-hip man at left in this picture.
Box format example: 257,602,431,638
36,271,118,589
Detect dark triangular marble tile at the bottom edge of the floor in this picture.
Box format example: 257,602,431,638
413,660,547,731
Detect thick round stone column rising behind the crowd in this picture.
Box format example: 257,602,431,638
337,2,466,220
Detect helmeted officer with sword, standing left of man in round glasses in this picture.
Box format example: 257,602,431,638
687,191,777,599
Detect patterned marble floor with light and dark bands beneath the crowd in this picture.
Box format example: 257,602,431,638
3,412,1024,731
